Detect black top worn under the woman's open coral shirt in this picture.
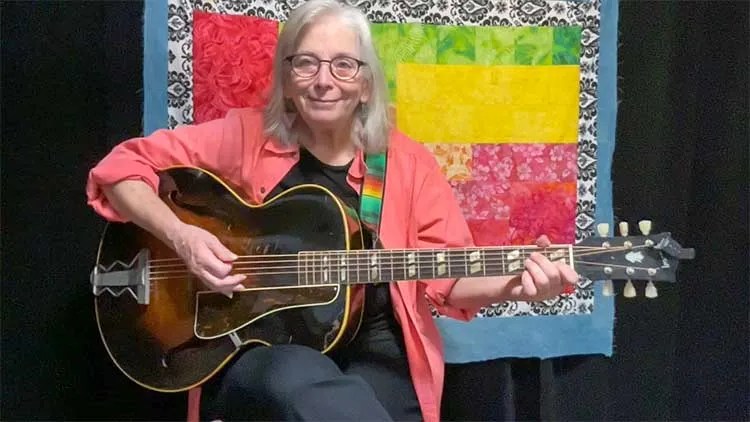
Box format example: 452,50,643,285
269,148,401,354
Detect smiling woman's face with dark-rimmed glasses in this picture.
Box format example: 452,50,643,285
284,16,369,134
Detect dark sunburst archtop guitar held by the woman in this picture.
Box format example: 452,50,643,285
90,167,693,392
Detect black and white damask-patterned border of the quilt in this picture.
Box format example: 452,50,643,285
167,0,600,317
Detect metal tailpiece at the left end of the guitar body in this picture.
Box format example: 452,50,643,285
90,249,151,305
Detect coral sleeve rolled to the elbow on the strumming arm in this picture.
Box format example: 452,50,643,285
86,113,241,222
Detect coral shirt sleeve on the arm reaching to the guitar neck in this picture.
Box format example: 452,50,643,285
412,157,480,321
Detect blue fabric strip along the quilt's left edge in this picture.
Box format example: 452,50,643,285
143,0,169,135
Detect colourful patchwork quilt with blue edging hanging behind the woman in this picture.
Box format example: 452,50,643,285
144,0,617,362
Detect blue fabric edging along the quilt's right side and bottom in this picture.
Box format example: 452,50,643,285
436,0,618,363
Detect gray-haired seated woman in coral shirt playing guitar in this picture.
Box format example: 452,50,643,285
87,0,577,421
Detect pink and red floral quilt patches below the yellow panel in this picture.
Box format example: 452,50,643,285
449,143,577,266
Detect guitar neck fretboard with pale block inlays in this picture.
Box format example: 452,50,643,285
297,245,573,285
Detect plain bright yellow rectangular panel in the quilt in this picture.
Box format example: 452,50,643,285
396,63,579,144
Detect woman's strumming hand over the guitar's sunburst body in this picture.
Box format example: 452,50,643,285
167,223,247,298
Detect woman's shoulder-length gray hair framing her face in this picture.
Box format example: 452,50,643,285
263,0,390,153
